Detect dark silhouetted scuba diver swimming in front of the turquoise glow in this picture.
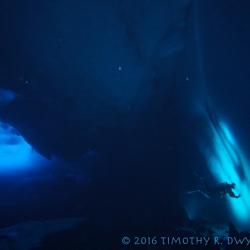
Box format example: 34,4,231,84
187,174,240,199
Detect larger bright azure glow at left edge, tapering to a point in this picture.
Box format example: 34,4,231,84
0,122,45,173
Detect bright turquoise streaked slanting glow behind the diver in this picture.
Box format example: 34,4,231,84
204,117,250,227
